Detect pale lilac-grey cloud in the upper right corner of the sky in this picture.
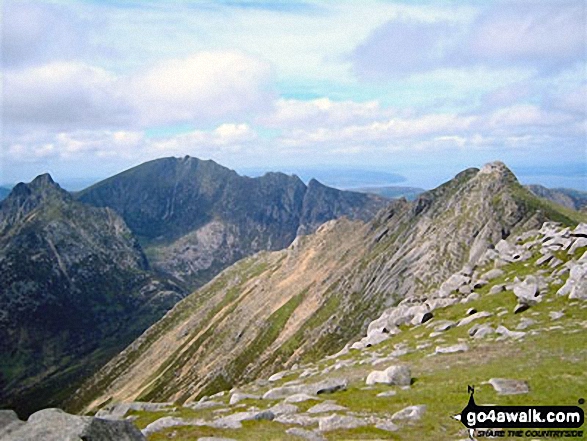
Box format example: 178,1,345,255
350,0,587,79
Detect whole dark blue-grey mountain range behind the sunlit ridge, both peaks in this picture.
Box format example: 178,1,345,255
0,157,386,414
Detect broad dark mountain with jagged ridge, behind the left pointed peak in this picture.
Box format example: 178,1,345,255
77,156,387,289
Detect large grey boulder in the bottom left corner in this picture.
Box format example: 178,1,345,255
0,409,146,441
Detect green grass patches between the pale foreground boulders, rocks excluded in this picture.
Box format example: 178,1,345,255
121,237,587,441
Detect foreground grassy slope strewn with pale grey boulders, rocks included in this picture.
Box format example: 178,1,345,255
79,223,587,441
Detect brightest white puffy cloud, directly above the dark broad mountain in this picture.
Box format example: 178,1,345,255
127,52,272,126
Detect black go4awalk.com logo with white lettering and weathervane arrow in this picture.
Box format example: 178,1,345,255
453,386,585,439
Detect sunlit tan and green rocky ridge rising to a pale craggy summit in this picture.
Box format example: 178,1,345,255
71,163,581,409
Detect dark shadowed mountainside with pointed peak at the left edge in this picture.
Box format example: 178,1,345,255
0,175,182,413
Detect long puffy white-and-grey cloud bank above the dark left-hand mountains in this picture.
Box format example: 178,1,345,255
3,52,273,130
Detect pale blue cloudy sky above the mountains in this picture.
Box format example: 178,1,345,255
0,0,587,190
